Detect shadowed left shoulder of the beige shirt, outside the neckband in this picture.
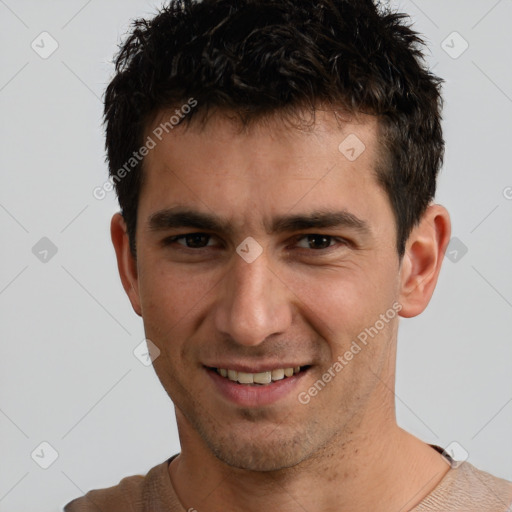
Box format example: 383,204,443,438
64,459,176,512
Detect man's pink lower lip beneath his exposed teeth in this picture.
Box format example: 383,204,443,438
206,368,310,407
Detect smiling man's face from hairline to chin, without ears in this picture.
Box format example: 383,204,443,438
120,113,408,470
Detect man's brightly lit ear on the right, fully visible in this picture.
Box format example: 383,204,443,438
400,204,451,318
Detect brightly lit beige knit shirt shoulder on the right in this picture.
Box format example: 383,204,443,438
413,462,512,512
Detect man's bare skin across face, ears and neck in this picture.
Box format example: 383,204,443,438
111,111,450,512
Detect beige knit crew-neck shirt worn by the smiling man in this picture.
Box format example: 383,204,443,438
64,445,512,512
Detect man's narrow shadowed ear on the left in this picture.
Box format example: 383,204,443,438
110,213,142,316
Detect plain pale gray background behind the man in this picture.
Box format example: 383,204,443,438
0,0,512,512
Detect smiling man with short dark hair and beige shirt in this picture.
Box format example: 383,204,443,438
65,0,512,512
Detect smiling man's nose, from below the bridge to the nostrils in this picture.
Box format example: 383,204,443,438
215,247,292,346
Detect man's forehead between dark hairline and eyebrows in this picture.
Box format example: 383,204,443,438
139,111,388,234
